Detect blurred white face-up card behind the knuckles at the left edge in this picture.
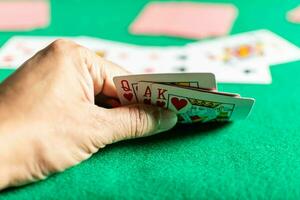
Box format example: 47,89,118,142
0,36,81,68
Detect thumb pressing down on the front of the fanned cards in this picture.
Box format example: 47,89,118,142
98,104,177,143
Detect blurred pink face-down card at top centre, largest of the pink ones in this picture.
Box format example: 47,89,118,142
130,2,237,39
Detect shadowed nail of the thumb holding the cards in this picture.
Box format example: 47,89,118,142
157,109,177,133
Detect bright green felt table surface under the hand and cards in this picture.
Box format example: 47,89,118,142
0,0,300,199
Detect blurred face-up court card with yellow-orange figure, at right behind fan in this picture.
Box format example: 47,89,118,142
187,30,300,66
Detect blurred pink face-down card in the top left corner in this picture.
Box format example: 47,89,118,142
0,0,50,31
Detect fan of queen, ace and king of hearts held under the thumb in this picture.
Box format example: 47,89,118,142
114,73,255,123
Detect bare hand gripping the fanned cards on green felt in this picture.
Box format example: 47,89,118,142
0,40,177,190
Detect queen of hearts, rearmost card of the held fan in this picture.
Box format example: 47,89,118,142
114,73,216,105
